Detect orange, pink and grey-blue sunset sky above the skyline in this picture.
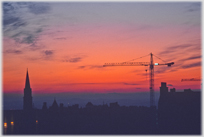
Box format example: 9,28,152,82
2,2,201,94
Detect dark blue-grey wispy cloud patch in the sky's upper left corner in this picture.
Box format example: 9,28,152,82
3,2,51,46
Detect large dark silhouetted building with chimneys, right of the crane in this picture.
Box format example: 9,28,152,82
158,82,201,134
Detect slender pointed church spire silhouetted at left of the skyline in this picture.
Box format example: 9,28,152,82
23,70,32,110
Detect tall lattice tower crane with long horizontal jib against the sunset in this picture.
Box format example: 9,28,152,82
103,53,174,106
